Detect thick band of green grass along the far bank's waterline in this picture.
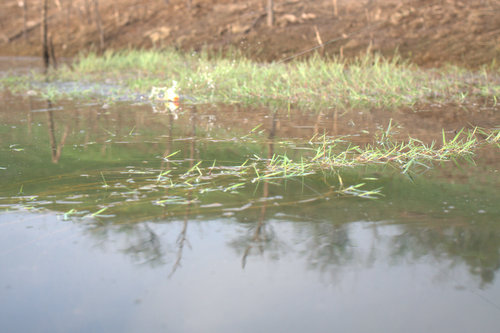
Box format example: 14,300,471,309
1,51,500,108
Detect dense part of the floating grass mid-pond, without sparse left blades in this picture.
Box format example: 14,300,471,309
148,123,492,198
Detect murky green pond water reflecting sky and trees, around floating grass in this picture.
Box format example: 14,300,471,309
0,66,500,332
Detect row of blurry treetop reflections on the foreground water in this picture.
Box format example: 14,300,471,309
71,201,500,289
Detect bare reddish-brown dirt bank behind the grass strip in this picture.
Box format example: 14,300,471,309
0,0,500,67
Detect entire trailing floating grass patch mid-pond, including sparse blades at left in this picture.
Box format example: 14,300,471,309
2,122,500,220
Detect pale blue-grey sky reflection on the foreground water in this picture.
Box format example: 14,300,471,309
0,213,500,332
